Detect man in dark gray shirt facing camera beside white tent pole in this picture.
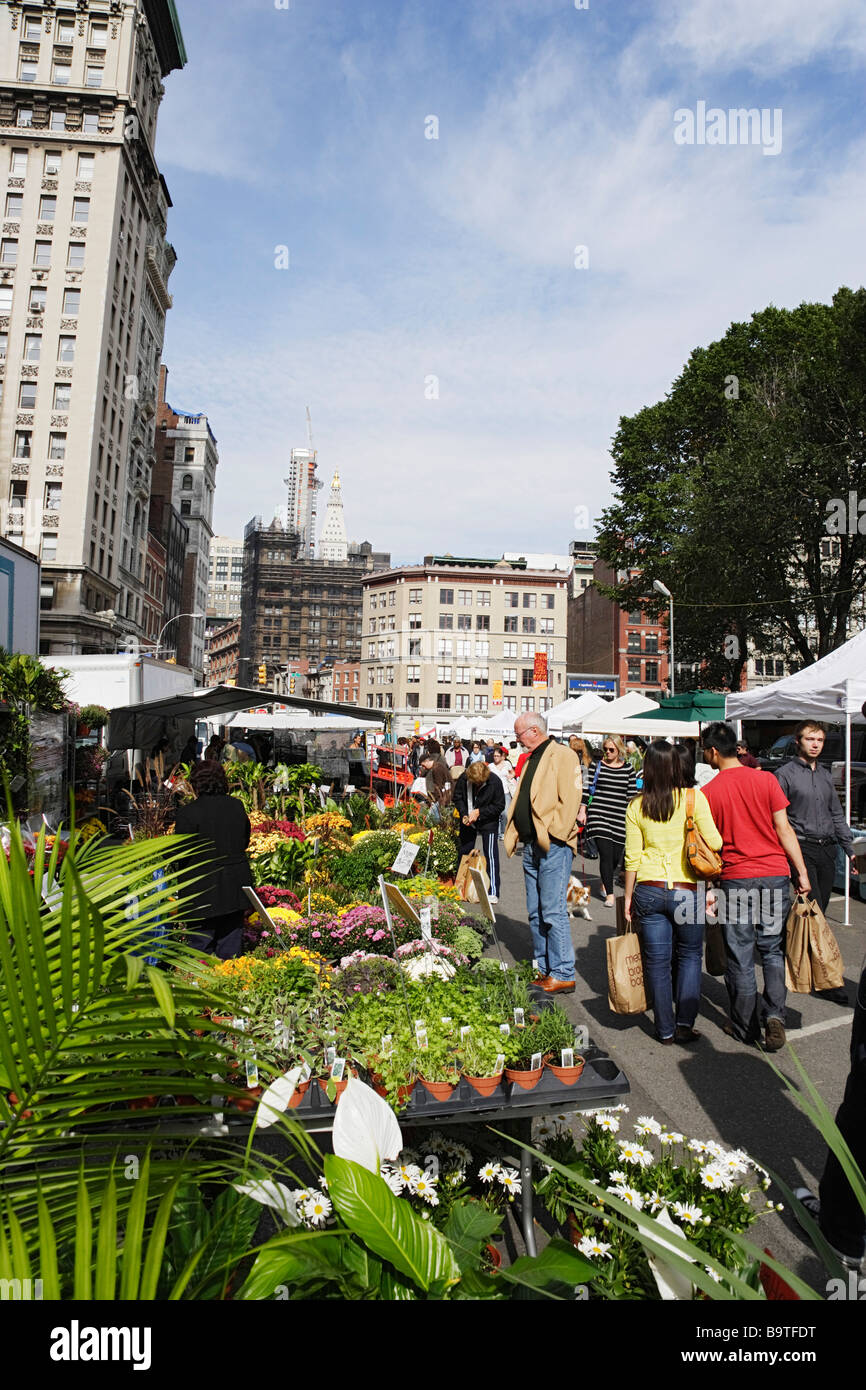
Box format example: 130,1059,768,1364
776,720,856,1004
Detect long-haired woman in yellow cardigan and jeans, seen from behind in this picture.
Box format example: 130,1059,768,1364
626,739,721,1047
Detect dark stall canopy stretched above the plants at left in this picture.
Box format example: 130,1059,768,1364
108,685,382,751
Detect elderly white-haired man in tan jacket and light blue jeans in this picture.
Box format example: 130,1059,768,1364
505,713,582,994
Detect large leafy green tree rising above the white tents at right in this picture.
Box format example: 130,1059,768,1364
599,289,866,689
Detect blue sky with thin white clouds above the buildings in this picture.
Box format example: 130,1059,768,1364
157,0,866,563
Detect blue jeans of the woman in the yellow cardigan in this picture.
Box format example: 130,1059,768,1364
632,883,703,1038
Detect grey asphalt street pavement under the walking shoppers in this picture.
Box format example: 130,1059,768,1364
475,845,866,1293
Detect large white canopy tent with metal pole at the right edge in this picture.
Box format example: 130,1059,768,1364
726,628,866,926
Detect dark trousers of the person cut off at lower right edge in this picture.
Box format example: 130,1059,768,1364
820,970,866,1259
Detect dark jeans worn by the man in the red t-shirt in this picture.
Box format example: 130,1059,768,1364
720,876,791,1043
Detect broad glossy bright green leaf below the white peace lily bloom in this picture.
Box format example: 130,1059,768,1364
324,1154,460,1293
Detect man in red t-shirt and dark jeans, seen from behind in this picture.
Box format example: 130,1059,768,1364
701,724,810,1052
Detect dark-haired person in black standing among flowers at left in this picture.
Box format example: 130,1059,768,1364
174,762,253,960
